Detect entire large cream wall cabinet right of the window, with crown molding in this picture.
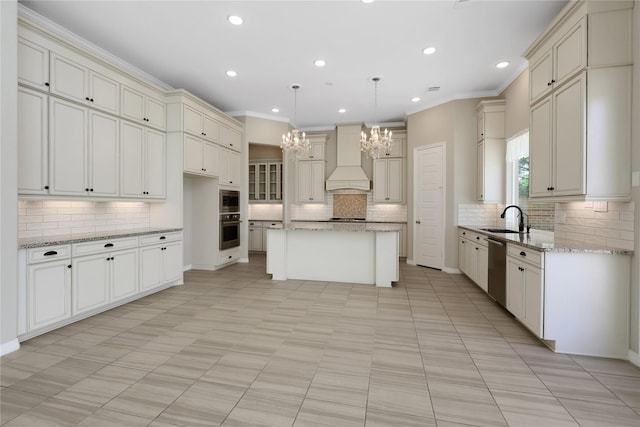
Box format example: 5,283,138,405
525,2,633,201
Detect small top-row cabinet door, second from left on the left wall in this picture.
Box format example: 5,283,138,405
50,52,89,102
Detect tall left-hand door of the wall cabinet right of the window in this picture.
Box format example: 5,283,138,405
529,96,553,197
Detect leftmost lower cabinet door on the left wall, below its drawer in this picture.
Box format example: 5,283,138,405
27,259,71,331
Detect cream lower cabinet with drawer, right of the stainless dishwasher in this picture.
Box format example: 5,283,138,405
507,245,544,338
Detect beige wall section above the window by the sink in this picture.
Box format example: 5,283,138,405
500,68,529,138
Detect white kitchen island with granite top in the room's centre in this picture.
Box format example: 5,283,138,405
267,222,400,287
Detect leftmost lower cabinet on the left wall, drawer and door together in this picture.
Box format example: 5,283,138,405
25,245,72,331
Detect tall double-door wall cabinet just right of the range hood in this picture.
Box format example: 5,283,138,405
373,158,405,203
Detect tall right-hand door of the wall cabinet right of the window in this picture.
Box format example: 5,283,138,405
552,73,587,196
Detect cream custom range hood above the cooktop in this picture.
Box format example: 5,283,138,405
326,123,371,191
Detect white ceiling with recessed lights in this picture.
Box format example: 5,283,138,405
21,0,567,129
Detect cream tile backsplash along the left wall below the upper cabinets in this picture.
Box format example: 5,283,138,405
18,200,150,238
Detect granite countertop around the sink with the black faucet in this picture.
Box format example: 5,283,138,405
459,225,633,255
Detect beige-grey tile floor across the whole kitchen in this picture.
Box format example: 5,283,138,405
0,256,640,427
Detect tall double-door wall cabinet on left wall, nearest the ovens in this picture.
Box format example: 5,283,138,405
120,121,167,199
